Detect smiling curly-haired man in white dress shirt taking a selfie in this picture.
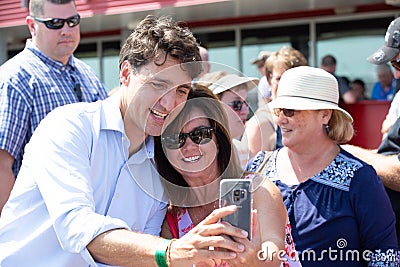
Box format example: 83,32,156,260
0,13,246,267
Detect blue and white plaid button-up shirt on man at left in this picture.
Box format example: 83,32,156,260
0,40,107,176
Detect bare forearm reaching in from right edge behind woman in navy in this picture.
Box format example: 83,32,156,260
342,145,400,192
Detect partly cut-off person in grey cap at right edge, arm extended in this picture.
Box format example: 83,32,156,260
344,15,400,247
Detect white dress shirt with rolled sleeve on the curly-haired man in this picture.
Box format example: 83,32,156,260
0,94,167,267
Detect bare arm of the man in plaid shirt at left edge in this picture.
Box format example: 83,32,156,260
0,149,15,215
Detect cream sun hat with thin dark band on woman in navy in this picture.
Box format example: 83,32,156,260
269,66,353,121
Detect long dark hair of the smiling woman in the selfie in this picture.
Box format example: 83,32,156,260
154,85,241,205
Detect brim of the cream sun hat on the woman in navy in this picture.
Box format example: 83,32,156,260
268,96,353,122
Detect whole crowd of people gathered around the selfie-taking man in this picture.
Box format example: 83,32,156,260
0,0,400,267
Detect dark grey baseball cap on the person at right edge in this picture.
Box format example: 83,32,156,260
367,18,400,65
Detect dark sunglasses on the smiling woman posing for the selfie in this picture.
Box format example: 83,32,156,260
161,126,215,149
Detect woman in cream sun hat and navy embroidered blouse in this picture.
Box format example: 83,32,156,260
249,66,397,267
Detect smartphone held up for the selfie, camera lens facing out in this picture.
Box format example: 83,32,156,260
219,179,253,239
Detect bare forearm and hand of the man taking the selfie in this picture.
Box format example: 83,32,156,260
87,206,244,267
